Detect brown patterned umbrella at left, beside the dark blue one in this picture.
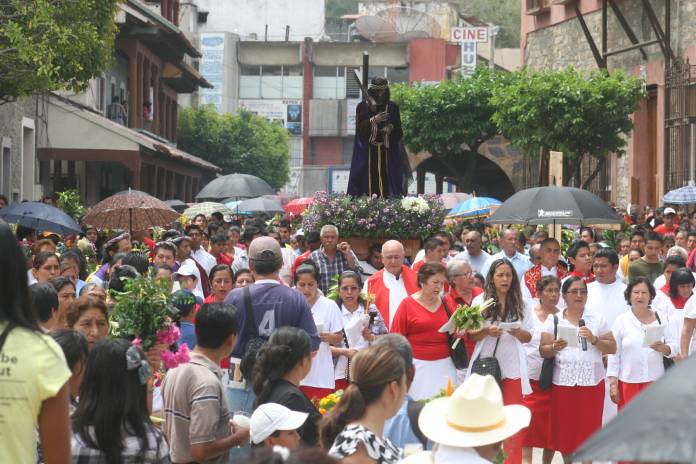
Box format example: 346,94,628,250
82,189,179,230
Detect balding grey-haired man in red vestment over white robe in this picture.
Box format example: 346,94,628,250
363,240,418,328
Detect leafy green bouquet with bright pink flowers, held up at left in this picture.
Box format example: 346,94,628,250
111,276,189,378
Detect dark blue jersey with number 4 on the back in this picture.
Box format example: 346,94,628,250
225,280,321,358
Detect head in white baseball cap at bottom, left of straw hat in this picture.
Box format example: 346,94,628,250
249,403,309,451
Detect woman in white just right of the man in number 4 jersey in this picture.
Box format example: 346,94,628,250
295,260,343,399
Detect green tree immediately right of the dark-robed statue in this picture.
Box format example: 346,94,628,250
392,68,508,191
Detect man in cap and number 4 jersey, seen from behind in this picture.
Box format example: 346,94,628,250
225,237,320,412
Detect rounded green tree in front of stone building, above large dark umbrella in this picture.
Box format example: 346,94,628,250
491,67,645,187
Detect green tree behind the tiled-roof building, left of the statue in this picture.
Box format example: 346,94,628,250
177,106,289,189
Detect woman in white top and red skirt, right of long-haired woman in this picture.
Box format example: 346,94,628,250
522,275,561,464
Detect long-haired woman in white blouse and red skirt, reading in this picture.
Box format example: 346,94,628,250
467,258,534,464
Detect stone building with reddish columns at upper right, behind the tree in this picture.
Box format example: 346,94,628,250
521,0,696,206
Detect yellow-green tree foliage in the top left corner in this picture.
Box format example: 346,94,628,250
0,0,122,103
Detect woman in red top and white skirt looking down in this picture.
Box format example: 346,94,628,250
391,262,457,401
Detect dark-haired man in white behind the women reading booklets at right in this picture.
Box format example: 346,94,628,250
585,248,630,424
